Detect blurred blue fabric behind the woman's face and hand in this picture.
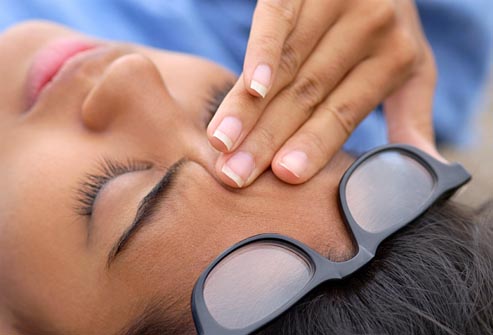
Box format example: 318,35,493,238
0,0,493,152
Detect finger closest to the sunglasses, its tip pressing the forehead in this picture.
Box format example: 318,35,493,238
272,57,399,184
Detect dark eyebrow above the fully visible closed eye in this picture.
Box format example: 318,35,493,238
106,158,188,268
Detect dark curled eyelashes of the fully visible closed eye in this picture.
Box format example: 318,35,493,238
76,158,152,217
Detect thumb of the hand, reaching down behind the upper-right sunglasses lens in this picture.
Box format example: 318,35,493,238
384,49,444,160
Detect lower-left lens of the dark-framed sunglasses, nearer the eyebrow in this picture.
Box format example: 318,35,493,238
204,241,313,329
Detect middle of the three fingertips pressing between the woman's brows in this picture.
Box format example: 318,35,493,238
213,24,367,187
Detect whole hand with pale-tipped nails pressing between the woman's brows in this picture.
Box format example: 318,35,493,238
207,0,438,187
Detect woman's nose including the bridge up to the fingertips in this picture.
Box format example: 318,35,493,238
81,54,217,176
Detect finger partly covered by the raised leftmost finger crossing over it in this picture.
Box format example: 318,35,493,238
207,1,338,153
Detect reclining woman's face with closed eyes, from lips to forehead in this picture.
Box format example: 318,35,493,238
0,23,351,334
